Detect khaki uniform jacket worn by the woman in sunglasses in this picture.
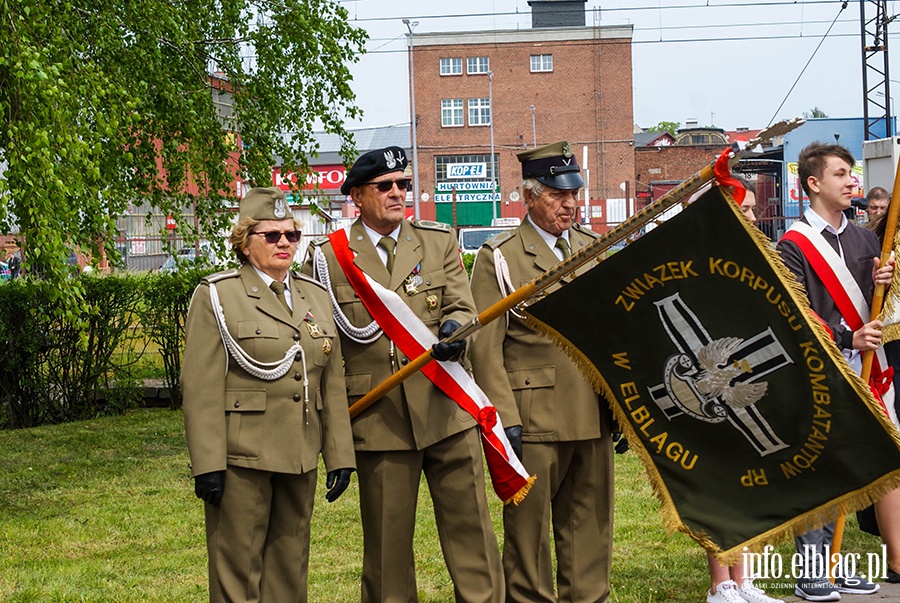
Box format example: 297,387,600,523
181,263,356,476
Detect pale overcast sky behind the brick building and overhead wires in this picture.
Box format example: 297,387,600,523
341,0,900,130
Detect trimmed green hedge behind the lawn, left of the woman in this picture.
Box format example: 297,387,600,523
0,270,212,429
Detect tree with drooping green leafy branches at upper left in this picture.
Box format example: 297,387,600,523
0,0,366,315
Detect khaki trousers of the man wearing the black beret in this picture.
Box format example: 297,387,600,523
356,428,504,603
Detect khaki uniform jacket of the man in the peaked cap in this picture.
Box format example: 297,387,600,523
471,220,601,442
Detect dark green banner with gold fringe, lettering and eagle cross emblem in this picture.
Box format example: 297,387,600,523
527,188,900,558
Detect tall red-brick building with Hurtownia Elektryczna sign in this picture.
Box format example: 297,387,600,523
411,0,634,232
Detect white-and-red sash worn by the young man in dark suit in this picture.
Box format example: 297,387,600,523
784,220,897,425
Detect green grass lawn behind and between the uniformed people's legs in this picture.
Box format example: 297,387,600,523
0,409,880,603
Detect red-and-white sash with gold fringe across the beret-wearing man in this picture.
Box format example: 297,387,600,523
317,228,535,504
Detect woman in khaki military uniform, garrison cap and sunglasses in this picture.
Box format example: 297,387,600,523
181,188,355,603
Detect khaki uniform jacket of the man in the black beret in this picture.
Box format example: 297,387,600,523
304,220,475,451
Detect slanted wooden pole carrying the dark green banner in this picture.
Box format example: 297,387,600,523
350,118,803,419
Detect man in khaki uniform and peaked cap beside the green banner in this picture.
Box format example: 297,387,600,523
472,141,613,603
